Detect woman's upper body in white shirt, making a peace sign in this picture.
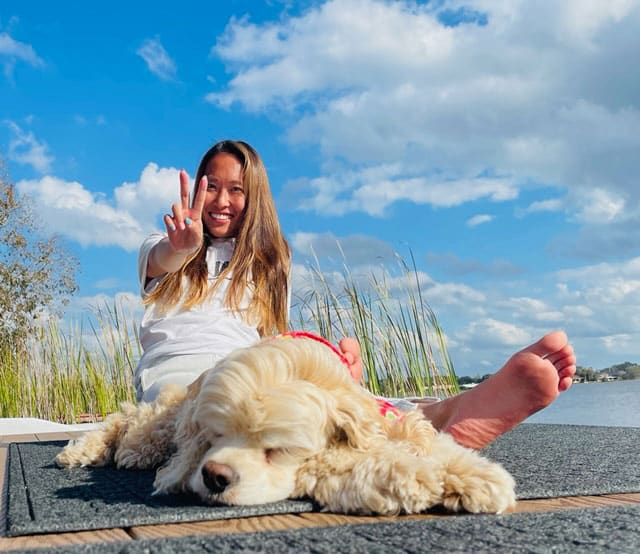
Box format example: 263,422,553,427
135,140,290,402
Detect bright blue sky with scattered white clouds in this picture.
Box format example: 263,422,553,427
0,0,640,375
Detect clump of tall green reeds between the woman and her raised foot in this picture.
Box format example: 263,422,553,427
296,252,459,397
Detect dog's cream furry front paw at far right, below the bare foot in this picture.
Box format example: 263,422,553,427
442,456,516,514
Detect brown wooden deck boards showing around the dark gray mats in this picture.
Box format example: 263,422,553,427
0,433,640,551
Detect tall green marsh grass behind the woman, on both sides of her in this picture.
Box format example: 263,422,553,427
0,256,458,423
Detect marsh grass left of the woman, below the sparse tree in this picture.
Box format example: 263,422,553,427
0,300,139,423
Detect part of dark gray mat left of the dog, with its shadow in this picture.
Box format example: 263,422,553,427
5,441,314,537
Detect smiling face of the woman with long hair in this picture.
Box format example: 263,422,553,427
202,152,246,238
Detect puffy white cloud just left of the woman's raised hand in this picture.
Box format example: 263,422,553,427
16,163,179,251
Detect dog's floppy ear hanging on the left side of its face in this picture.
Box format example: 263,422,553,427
153,370,209,494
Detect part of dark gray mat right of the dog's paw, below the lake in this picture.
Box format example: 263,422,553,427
482,423,640,499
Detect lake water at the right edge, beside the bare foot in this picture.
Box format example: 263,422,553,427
527,380,640,427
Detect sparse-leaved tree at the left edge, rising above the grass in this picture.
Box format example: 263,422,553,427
0,162,77,349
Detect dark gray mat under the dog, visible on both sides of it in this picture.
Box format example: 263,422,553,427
6,424,640,536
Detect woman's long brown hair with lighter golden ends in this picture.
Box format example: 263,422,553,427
144,140,291,336
